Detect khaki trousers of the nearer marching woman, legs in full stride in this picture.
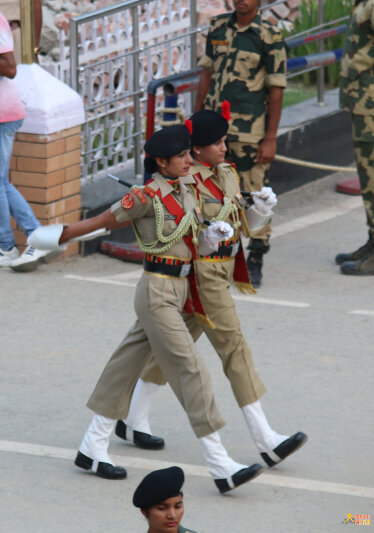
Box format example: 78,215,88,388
87,273,225,437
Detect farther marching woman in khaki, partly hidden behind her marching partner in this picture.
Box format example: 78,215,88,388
116,102,307,467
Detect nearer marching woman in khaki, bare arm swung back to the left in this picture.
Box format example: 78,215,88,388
30,125,263,492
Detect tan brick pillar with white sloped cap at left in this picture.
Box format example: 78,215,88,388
10,64,84,256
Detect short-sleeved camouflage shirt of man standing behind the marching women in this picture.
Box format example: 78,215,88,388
199,12,287,143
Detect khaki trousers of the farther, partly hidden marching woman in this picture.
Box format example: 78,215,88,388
141,260,266,407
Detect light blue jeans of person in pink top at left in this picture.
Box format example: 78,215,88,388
0,120,40,251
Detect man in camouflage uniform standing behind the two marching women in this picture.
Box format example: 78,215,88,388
195,0,287,287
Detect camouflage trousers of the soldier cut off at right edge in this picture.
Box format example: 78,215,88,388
352,114,374,237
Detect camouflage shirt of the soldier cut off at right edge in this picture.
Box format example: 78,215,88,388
340,0,374,115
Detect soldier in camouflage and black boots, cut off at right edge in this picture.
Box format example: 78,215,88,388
335,0,374,276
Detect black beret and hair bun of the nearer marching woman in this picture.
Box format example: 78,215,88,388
144,124,191,174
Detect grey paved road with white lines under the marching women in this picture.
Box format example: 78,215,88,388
0,171,374,533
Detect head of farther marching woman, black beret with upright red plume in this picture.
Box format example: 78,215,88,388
191,101,230,167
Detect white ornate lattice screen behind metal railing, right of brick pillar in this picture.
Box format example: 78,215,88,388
70,0,198,179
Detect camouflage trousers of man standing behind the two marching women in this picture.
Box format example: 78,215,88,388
226,141,271,254
